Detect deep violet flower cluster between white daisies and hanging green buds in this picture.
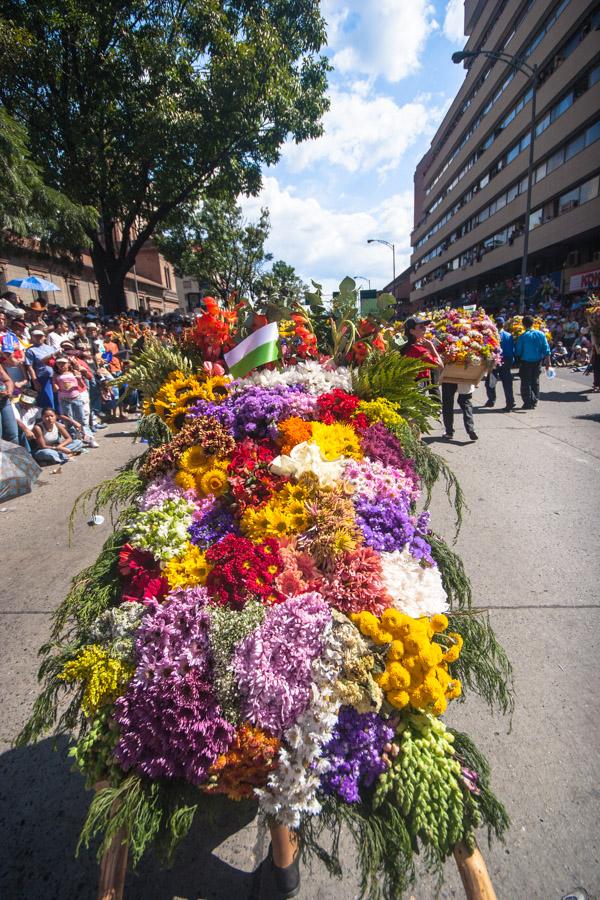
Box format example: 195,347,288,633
321,706,394,803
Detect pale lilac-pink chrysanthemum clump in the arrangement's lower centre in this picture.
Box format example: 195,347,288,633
233,592,331,737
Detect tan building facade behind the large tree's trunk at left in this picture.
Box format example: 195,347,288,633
0,240,180,316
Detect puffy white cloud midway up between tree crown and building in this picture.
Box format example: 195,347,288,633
283,82,444,174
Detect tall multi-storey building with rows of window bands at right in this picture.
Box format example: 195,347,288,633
411,0,600,306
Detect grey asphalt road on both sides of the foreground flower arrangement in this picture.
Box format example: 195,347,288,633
0,371,600,900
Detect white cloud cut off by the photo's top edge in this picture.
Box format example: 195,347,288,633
322,0,438,82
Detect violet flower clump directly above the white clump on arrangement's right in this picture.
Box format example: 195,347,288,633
354,492,435,566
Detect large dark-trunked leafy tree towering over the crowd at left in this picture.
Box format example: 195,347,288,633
0,0,329,310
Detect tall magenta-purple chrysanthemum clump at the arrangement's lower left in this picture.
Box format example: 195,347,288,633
115,587,235,784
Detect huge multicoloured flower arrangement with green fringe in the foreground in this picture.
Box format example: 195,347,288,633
25,313,510,896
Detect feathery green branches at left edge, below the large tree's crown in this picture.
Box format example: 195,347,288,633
0,108,96,257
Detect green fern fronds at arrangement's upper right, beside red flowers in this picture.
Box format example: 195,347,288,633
352,350,439,432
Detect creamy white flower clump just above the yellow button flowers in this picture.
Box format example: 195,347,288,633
381,549,448,619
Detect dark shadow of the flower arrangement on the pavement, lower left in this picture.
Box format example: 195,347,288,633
0,738,256,900
